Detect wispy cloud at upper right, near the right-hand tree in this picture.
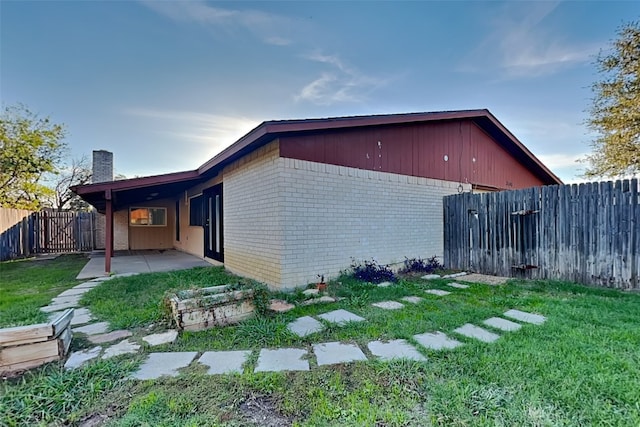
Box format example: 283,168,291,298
459,2,600,78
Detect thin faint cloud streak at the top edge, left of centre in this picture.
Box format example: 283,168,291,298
140,0,292,46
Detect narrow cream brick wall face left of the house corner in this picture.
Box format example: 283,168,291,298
223,140,283,288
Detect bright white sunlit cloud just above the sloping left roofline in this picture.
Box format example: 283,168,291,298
125,108,259,160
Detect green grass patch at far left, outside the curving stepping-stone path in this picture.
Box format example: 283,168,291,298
0,254,87,328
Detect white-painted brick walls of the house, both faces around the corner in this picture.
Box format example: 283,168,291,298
224,141,470,289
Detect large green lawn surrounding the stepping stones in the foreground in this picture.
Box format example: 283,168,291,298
0,262,640,426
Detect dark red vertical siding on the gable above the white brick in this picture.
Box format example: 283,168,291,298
280,120,544,189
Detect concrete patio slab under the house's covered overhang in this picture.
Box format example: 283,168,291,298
76,250,212,280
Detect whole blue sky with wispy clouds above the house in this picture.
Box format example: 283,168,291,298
0,0,640,182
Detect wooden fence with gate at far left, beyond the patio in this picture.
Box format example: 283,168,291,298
0,208,95,261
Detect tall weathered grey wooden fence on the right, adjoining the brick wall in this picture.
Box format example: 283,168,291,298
444,179,640,289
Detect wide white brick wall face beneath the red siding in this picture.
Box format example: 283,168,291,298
278,158,471,289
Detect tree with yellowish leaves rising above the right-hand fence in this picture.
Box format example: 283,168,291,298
585,22,640,177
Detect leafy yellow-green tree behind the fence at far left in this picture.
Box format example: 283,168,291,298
0,105,66,210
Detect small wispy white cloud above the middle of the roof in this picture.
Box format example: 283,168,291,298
295,53,387,105
